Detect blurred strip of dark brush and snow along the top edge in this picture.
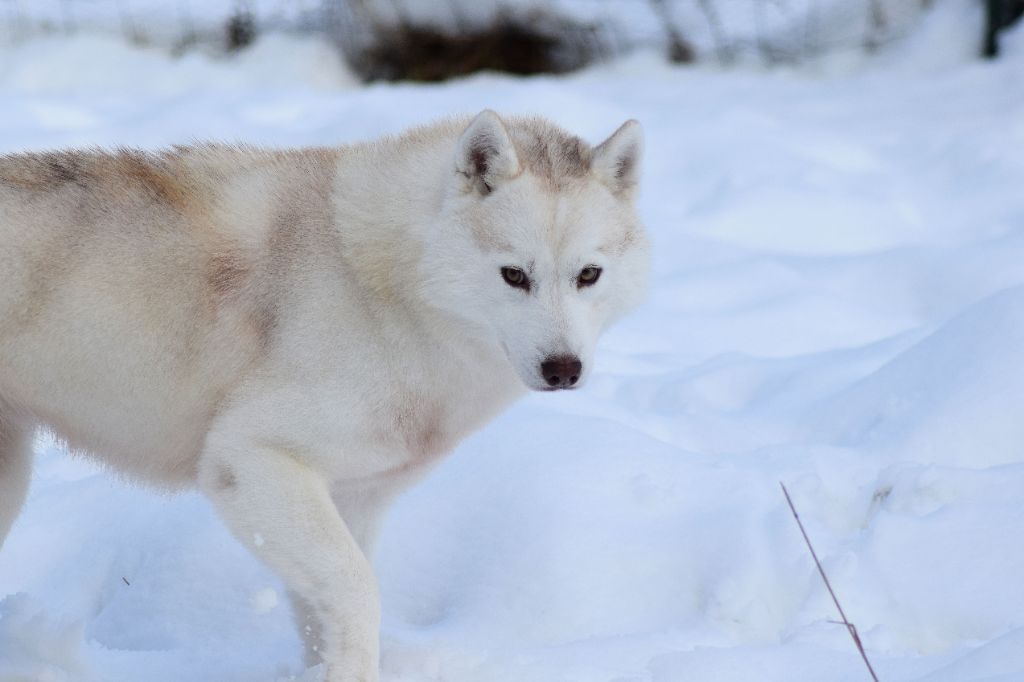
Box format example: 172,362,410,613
0,0,1024,81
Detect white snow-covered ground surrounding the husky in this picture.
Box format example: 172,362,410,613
0,11,1024,682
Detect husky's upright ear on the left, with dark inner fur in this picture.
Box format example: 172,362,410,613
455,109,519,195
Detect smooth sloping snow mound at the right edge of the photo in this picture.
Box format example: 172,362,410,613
815,288,1024,467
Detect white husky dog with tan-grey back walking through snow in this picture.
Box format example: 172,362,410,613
0,111,648,682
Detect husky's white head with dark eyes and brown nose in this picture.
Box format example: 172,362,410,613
423,111,648,390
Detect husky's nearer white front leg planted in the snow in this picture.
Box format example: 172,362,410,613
200,438,380,682
